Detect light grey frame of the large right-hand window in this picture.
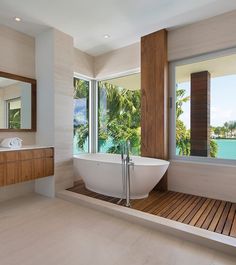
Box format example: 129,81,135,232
169,47,236,165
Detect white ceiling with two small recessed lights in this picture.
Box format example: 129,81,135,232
0,0,236,56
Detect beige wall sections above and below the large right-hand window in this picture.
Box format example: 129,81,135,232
168,11,236,202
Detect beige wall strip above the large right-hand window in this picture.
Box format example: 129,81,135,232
168,11,236,61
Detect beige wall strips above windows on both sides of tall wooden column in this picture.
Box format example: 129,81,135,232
91,11,236,79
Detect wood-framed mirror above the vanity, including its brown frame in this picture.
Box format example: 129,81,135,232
0,71,36,132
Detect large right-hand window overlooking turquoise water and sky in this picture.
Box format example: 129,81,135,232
175,50,236,159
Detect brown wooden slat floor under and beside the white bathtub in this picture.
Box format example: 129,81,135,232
68,181,236,238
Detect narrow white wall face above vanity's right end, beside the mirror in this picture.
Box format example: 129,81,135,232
35,31,55,146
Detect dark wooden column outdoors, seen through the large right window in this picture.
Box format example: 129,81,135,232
191,71,210,156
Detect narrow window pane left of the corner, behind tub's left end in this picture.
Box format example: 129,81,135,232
73,77,90,154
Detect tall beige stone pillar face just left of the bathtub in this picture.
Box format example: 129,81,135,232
52,30,74,190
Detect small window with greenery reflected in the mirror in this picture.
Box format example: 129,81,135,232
6,98,21,129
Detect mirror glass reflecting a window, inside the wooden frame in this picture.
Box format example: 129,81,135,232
0,77,32,129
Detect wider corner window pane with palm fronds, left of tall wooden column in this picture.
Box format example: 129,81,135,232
98,74,141,155
